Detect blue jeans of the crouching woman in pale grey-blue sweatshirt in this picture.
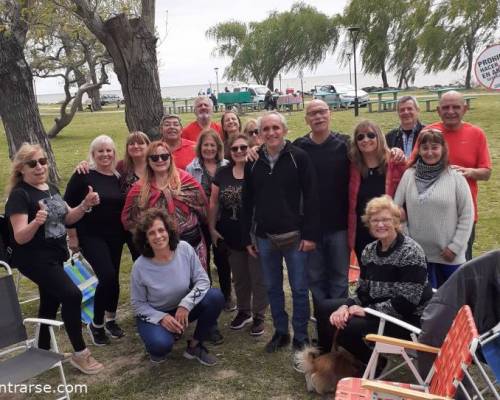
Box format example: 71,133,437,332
136,288,224,357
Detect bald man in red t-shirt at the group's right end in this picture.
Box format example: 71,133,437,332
427,90,491,260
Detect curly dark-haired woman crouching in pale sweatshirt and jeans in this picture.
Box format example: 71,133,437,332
130,209,224,366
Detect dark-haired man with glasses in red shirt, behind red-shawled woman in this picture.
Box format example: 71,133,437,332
160,114,196,170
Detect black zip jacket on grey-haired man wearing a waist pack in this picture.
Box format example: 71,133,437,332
242,141,320,246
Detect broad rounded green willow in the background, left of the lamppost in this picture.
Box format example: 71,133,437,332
206,3,338,89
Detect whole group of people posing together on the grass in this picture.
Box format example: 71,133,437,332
2,92,491,374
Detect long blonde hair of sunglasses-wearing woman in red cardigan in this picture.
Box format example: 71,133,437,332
349,119,390,177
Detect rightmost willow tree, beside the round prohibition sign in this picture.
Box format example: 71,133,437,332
419,0,499,88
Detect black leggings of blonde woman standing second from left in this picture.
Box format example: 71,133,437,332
79,235,124,325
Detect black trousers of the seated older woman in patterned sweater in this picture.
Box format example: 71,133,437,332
318,299,420,364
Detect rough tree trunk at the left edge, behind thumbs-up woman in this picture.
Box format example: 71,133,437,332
0,0,59,183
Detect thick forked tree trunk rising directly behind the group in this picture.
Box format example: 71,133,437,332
72,0,163,138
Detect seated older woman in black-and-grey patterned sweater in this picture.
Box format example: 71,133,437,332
319,195,432,363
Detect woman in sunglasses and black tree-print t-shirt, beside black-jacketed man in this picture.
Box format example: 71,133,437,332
209,133,268,336
